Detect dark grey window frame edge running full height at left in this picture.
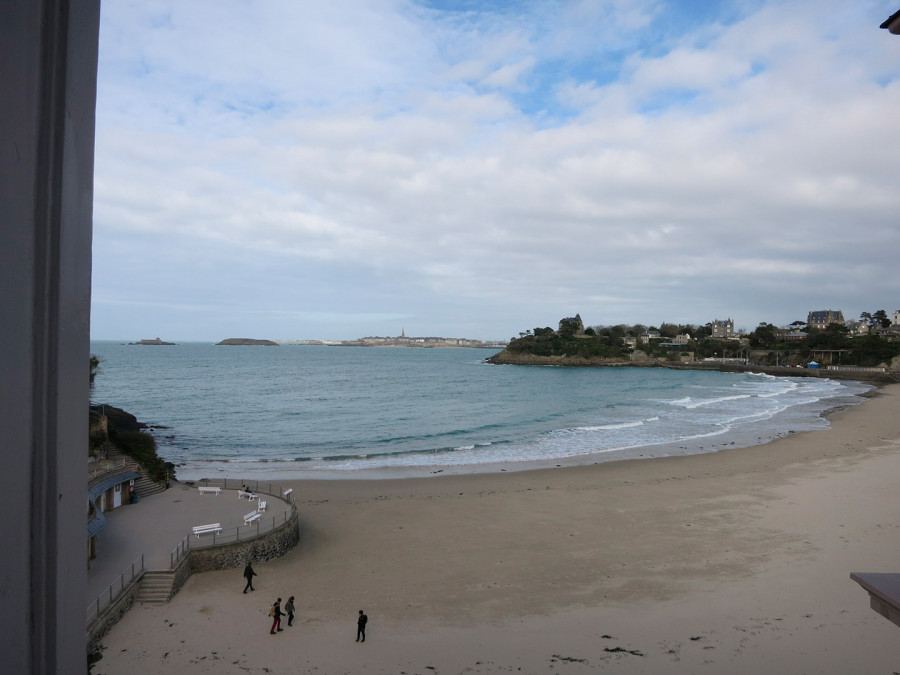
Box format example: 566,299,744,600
0,0,100,675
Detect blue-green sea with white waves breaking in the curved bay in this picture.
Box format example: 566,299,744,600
91,341,871,480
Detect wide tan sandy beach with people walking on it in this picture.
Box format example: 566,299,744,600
93,385,900,675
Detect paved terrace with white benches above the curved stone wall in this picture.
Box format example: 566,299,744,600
86,481,291,603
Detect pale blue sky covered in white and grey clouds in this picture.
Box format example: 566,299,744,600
91,0,900,341
